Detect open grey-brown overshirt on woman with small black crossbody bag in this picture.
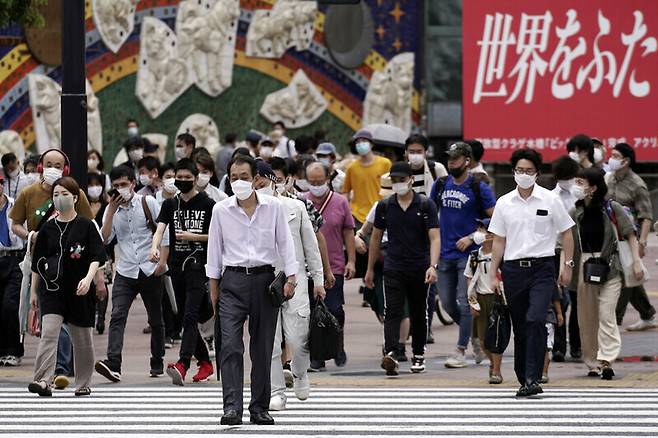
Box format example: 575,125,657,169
569,201,635,290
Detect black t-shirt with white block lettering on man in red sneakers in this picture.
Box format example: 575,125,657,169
158,192,215,270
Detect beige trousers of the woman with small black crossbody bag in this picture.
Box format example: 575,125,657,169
578,253,622,369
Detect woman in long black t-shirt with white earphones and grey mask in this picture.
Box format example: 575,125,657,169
28,177,105,396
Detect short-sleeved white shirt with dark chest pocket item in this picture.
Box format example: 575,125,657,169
489,184,575,261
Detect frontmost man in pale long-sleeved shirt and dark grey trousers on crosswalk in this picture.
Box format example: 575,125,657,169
206,155,296,425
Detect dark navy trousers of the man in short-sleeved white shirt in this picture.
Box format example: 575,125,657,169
501,261,555,385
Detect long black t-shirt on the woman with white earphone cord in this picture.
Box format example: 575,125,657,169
32,215,106,327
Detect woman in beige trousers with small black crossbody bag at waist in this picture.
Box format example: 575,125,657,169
570,167,644,380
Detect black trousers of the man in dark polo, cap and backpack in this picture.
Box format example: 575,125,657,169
384,270,428,356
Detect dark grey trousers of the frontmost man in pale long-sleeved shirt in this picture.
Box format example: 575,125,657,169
219,271,277,414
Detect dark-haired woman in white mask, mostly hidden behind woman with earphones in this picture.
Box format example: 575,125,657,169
87,172,116,335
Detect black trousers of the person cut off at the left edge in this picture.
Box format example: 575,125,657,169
0,253,24,357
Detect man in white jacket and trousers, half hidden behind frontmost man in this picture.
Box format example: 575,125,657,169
254,160,326,411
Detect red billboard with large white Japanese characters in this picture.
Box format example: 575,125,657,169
462,0,658,161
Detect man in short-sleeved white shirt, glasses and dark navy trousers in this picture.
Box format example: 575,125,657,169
489,149,574,397
